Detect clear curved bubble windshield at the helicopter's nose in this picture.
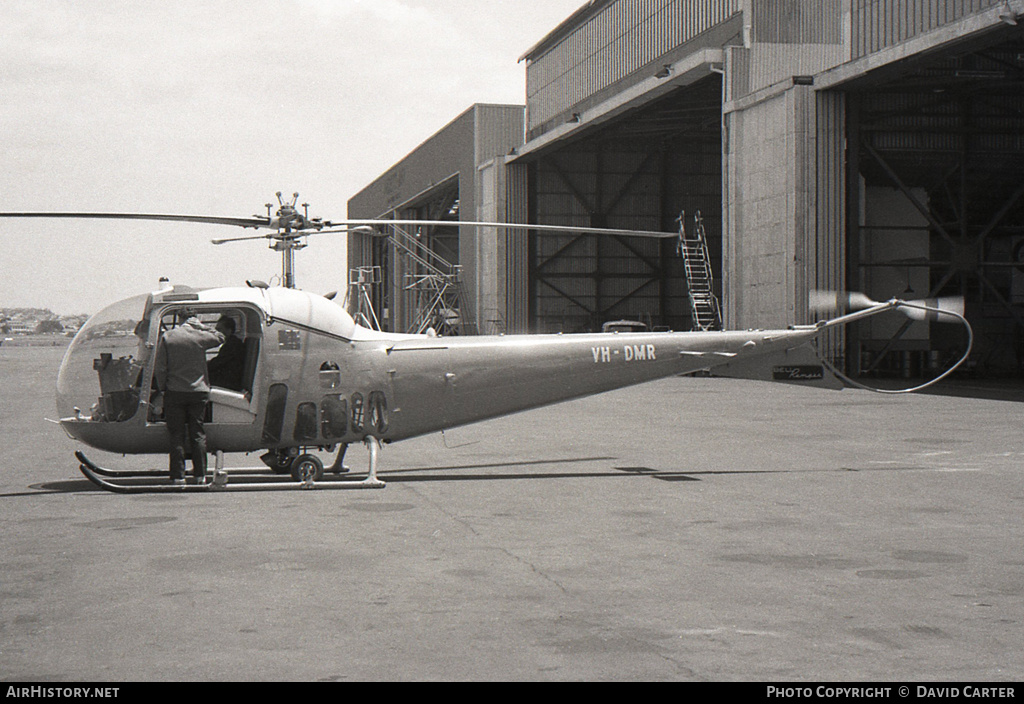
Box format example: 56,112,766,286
57,296,153,423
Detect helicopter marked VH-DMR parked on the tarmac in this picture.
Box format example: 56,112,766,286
0,192,973,493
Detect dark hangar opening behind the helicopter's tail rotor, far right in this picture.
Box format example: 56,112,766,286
848,28,1024,378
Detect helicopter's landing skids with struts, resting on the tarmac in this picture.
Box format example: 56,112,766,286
75,437,387,494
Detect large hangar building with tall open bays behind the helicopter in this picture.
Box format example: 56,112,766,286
348,0,1024,376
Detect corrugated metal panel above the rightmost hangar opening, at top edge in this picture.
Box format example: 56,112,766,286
851,0,1002,58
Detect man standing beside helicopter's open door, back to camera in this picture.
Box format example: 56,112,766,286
156,309,224,484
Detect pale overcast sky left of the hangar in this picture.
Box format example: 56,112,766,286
0,0,586,314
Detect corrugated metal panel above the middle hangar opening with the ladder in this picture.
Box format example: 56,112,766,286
526,0,740,138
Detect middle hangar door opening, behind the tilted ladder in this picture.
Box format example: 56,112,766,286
528,75,722,333
